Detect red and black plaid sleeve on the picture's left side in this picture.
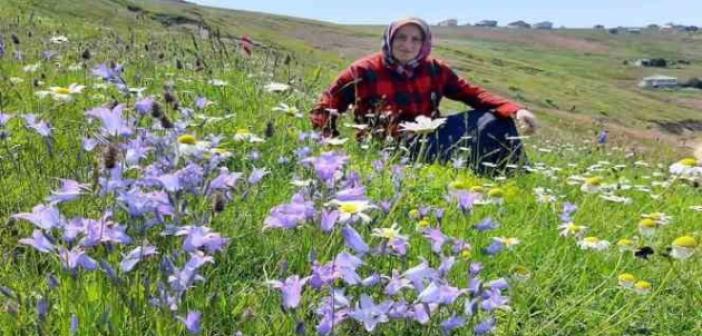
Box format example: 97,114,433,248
310,65,360,136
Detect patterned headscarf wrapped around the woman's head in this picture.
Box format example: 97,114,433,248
383,17,431,78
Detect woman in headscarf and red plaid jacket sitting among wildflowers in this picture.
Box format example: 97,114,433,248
311,18,536,172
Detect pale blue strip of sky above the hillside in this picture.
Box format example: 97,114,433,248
188,0,702,27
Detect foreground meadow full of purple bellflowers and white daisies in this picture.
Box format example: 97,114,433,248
0,2,702,335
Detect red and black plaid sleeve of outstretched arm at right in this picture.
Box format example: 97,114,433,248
440,60,522,118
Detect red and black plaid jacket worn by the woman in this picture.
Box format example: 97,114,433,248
310,53,521,135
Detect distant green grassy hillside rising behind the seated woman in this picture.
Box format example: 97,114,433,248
3,0,702,146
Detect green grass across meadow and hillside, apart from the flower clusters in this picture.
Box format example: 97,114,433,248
0,1,702,335
